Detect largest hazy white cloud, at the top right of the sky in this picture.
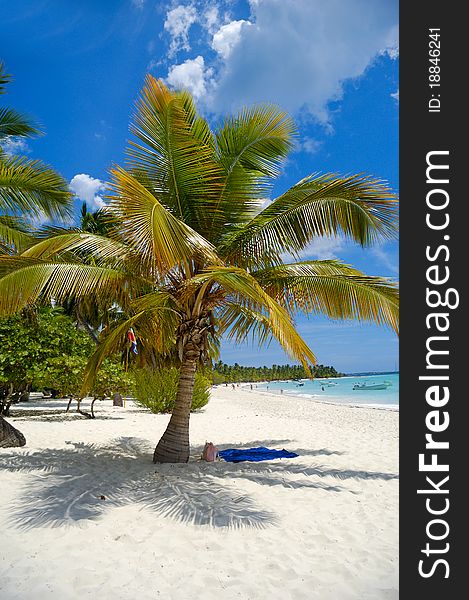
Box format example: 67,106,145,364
210,0,398,123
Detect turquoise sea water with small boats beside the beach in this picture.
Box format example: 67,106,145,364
256,373,399,410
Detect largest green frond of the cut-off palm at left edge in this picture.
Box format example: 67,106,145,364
0,157,72,218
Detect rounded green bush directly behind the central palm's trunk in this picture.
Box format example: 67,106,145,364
134,367,212,413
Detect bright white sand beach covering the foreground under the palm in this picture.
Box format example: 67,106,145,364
0,387,398,600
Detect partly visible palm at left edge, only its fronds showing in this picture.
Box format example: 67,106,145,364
0,62,71,250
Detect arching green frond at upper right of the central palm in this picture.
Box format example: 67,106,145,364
219,174,397,265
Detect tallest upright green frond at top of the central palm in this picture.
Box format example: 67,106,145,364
128,75,222,235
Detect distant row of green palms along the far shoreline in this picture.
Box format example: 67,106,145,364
213,361,342,384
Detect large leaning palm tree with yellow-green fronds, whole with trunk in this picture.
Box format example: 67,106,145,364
0,76,398,462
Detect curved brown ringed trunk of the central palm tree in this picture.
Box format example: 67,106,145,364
153,358,196,463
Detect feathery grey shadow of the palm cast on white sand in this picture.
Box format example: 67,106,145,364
0,438,397,529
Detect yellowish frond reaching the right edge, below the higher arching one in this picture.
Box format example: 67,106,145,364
252,260,399,332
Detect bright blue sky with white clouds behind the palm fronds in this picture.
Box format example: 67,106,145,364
0,0,399,372
